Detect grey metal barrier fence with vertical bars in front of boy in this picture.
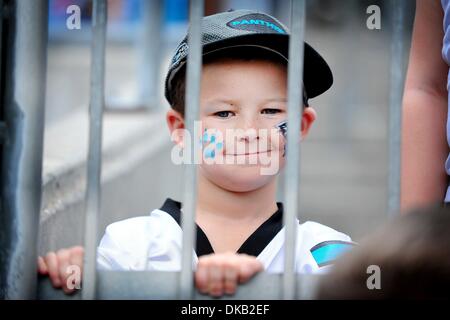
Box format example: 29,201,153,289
0,0,404,299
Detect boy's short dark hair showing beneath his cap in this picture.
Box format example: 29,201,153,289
166,47,287,116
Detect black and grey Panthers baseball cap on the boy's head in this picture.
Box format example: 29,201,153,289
164,9,333,104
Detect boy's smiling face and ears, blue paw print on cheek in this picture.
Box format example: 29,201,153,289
167,60,316,192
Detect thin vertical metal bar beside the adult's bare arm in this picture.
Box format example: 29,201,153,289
388,0,405,215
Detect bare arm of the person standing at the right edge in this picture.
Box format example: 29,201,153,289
401,0,450,211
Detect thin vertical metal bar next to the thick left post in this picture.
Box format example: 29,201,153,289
82,0,107,299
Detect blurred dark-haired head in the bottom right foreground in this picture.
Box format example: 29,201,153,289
317,206,450,299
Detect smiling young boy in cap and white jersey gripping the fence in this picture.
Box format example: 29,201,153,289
39,10,352,296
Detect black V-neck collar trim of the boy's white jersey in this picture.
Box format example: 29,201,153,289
160,198,283,257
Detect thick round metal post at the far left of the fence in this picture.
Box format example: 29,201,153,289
0,0,48,299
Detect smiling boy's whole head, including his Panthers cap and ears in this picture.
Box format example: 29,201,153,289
166,10,331,192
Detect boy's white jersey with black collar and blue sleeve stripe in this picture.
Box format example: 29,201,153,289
97,199,354,273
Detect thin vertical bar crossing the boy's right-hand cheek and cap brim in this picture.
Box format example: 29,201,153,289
283,0,306,299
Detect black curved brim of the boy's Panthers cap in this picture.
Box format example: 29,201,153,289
203,33,333,98
